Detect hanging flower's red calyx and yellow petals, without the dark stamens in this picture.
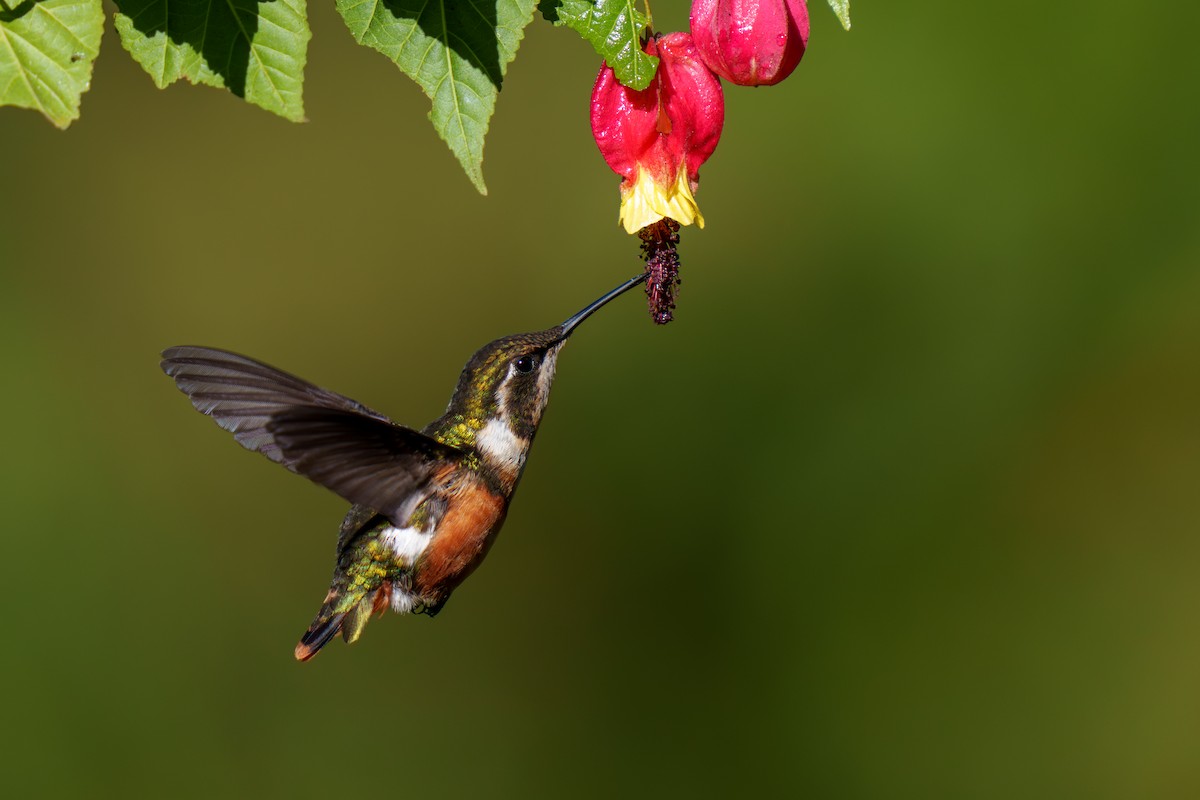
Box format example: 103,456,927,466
592,34,725,234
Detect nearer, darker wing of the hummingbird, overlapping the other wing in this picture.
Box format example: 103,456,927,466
266,407,462,525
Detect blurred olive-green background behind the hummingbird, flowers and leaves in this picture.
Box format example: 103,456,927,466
0,0,1200,799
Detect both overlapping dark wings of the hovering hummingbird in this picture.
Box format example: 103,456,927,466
161,347,462,525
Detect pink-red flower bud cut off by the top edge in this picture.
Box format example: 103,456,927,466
691,0,809,86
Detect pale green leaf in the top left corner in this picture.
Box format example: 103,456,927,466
0,0,104,128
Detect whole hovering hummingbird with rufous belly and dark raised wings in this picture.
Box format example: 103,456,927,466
161,273,646,661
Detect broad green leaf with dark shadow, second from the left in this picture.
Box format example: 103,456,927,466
115,0,312,122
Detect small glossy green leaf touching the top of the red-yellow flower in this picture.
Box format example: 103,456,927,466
541,0,659,90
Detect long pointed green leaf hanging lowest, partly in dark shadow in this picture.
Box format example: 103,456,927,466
337,0,535,194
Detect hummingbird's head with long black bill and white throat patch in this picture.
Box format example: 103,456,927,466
433,273,646,480
